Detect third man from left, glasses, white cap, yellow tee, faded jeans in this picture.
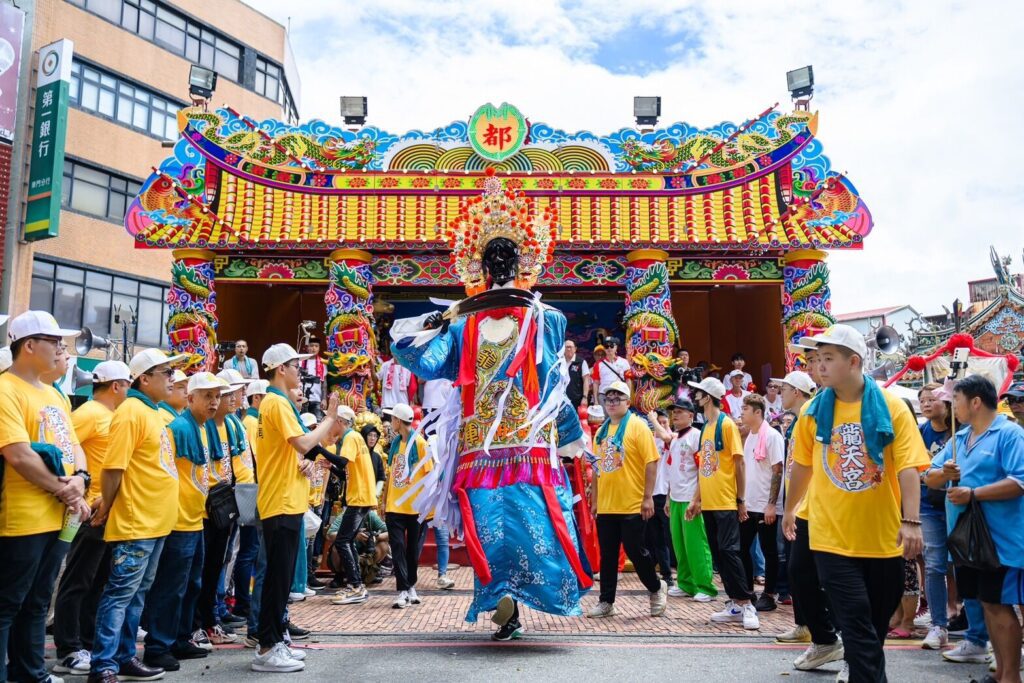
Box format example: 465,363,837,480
89,348,185,683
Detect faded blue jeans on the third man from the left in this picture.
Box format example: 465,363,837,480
90,537,166,674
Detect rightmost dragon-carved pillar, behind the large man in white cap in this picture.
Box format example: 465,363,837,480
782,249,836,370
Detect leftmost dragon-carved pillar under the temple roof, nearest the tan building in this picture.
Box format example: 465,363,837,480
167,249,217,374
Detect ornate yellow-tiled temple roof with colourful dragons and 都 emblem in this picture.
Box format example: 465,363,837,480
125,104,871,253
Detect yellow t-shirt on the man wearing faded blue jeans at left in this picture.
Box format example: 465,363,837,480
103,397,178,542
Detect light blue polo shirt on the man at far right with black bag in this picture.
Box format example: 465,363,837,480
932,415,1024,568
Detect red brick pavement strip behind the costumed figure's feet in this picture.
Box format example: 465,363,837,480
291,567,793,637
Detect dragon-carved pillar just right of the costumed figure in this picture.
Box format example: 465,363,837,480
625,249,679,414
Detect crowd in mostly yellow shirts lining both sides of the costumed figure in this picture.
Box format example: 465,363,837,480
0,311,1024,683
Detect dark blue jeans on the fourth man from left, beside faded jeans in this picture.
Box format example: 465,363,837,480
143,531,205,656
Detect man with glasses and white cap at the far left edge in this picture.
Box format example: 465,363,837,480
0,310,90,681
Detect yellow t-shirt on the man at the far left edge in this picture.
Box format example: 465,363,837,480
0,372,78,537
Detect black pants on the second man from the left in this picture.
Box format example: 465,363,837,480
53,522,111,659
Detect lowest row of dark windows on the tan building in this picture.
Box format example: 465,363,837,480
30,259,169,347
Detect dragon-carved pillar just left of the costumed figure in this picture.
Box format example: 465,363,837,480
324,249,378,413
